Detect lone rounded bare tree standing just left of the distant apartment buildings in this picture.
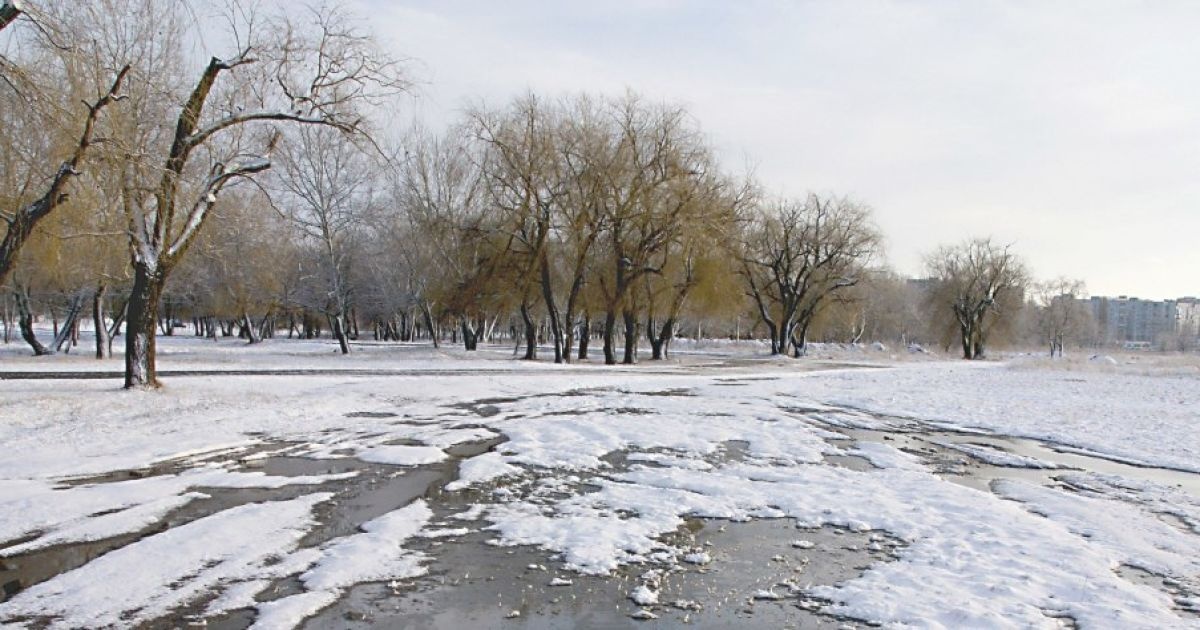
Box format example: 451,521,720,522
925,239,1028,359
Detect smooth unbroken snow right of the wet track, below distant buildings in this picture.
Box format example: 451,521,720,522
777,362,1200,472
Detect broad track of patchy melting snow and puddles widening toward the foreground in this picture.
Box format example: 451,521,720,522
0,374,1200,629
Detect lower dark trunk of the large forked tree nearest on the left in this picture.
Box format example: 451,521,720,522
125,263,167,389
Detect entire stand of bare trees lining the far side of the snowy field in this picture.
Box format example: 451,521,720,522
0,0,1104,386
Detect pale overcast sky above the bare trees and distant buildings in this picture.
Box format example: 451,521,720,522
359,0,1200,299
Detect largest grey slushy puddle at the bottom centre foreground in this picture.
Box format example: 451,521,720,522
305,518,894,630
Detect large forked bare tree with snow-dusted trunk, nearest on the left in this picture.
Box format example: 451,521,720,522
79,0,404,388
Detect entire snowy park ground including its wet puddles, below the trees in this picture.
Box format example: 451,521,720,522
0,340,1200,628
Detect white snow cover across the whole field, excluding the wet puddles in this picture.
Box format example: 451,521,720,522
0,340,1200,629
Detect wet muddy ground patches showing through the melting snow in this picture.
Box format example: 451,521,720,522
0,384,1200,629
